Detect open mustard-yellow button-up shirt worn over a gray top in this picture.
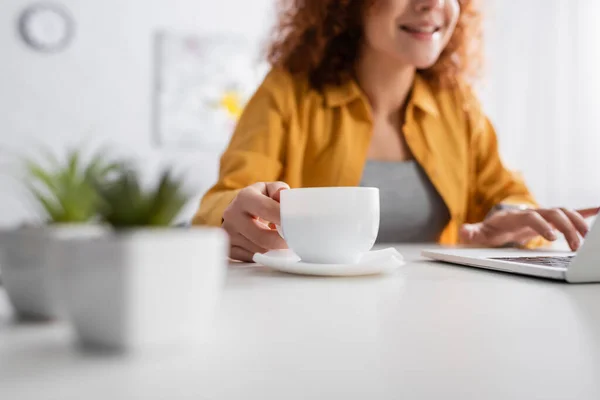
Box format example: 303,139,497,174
193,69,535,244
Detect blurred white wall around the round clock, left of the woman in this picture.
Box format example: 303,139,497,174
0,0,272,225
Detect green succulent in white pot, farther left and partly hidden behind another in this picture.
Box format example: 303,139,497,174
0,150,117,320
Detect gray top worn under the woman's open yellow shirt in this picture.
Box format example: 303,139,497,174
361,161,450,243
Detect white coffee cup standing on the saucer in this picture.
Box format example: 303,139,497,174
279,187,379,264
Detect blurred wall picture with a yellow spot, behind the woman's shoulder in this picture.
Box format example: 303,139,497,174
154,31,268,152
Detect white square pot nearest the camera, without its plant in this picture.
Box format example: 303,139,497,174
57,228,228,351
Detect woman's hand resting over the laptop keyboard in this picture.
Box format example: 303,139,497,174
459,208,600,251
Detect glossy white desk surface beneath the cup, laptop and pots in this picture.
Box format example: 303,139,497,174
0,246,600,400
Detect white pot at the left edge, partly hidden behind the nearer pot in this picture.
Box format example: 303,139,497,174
0,224,104,320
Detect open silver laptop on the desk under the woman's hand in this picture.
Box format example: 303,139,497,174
421,219,600,283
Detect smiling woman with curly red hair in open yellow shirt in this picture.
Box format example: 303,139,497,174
194,0,588,261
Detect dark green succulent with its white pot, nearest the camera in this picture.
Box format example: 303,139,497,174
55,169,228,351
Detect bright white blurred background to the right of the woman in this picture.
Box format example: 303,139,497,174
482,0,600,207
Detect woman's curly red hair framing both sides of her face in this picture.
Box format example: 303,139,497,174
268,0,483,88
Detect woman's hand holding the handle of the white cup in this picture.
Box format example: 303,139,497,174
222,182,290,262
